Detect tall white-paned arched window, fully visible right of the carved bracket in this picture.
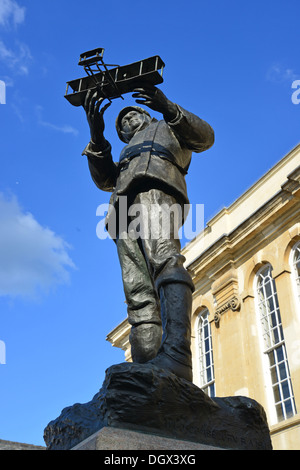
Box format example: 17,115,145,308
257,264,296,421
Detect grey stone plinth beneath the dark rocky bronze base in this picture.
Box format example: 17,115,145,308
71,427,223,451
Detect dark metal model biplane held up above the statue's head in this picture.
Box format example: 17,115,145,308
65,48,165,106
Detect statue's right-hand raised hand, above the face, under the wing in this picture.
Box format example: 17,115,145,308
132,86,177,121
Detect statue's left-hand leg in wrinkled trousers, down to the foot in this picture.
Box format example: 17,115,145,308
117,234,162,363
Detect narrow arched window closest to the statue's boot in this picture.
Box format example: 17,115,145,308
197,309,215,397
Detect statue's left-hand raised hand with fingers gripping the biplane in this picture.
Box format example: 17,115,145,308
83,90,111,146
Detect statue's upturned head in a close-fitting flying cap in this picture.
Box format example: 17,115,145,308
116,106,151,144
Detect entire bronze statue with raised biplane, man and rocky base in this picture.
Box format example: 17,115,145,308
44,52,272,450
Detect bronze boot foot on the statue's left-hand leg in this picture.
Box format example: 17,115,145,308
129,323,162,364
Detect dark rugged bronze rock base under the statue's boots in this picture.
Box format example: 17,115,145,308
44,362,272,450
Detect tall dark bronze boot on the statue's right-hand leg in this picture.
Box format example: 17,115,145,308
148,282,193,382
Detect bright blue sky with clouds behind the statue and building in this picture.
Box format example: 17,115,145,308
0,0,300,445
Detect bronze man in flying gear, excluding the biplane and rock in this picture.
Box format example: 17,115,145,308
83,87,214,381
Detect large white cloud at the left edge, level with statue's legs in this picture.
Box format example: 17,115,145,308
0,193,75,297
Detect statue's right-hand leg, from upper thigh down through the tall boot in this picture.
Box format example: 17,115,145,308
139,189,194,381
